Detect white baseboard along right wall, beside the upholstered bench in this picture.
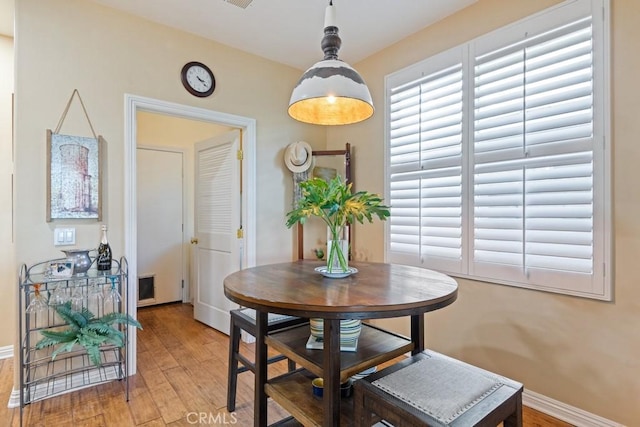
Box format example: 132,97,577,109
522,389,624,427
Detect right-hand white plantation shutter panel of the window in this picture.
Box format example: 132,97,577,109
470,17,594,287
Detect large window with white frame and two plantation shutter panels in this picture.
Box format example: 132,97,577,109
386,0,611,299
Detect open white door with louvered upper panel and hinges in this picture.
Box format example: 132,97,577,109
192,130,243,334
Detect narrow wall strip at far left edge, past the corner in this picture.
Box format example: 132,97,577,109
0,36,18,347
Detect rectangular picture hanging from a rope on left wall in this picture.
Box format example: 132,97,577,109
47,129,104,222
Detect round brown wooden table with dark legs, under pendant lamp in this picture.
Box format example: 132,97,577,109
224,261,458,426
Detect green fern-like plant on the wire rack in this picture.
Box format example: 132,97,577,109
36,301,142,366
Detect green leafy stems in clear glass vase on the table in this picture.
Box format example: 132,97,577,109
287,176,390,273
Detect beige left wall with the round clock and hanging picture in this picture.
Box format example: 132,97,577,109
16,0,325,263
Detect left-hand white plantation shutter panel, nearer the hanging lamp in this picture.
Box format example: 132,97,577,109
389,49,463,271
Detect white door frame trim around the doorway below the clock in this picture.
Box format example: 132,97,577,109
124,94,256,375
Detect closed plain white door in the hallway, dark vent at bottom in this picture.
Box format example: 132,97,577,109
136,148,184,306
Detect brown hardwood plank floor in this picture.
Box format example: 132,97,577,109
0,304,570,427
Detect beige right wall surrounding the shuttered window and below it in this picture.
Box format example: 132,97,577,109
327,0,640,426
